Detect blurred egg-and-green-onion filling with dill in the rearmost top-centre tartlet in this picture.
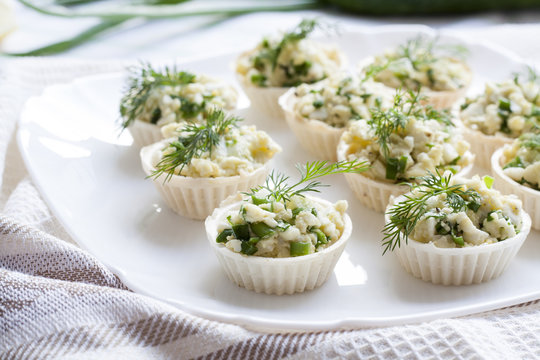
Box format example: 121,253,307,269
236,20,341,87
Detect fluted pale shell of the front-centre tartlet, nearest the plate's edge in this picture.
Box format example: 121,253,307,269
205,197,352,295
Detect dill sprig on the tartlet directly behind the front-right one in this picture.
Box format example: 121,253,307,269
368,89,453,160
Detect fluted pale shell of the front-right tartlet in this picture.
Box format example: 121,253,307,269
385,196,531,285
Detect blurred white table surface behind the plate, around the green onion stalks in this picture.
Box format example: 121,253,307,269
0,3,540,61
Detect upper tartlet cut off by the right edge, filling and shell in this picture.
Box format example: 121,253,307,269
459,69,540,168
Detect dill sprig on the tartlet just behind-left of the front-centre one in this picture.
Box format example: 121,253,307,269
149,109,238,181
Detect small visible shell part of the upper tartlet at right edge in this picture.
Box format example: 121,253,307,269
460,124,514,169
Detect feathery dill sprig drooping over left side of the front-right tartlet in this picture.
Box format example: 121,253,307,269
382,172,480,255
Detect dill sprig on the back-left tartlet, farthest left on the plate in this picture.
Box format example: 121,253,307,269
120,64,196,129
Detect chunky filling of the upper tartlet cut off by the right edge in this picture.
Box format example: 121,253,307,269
460,76,540,138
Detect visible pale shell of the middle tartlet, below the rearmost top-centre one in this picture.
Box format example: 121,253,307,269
279,88,345,161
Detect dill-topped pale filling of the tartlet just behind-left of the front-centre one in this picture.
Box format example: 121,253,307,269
152,111,281,178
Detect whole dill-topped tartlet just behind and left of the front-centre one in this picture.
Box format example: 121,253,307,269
141,110,281,220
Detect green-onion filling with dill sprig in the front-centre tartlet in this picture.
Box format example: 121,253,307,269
216,161,367,258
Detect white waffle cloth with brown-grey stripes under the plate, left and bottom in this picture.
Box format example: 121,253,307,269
0,53,540,359
